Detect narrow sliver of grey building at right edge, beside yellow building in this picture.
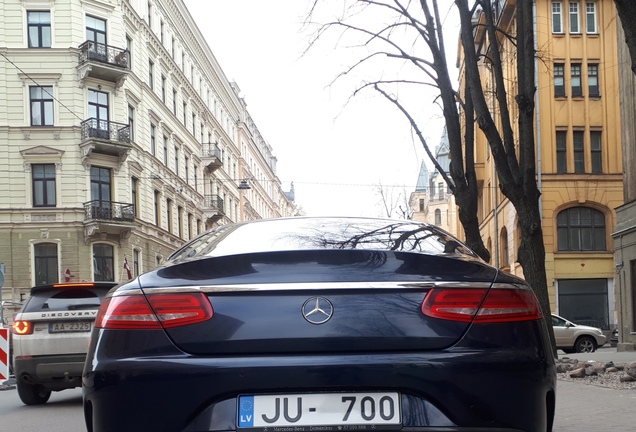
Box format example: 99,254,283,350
612,17,636,350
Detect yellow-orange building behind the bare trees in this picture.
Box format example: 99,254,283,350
460,0,623,331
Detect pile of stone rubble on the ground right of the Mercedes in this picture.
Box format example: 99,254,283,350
556,357,636,389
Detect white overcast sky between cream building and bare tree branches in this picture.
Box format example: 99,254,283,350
185,0,454,216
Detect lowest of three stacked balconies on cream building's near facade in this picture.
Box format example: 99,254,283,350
84,200,136,244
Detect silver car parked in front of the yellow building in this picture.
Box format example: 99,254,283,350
552,314,607,354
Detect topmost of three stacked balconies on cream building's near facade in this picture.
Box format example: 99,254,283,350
77,41,130,88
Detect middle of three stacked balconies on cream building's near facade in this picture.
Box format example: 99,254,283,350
80,118,132,166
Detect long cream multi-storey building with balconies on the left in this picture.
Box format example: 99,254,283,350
0,0,296,317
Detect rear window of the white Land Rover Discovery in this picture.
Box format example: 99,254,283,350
24,288,108,312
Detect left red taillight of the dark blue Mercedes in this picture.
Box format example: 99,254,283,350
95,293,214,329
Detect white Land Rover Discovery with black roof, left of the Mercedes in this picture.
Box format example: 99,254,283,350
12,282,116,405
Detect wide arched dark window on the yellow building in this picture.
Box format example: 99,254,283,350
557,207,607,252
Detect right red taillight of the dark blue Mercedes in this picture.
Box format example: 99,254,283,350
422,288,542,323
